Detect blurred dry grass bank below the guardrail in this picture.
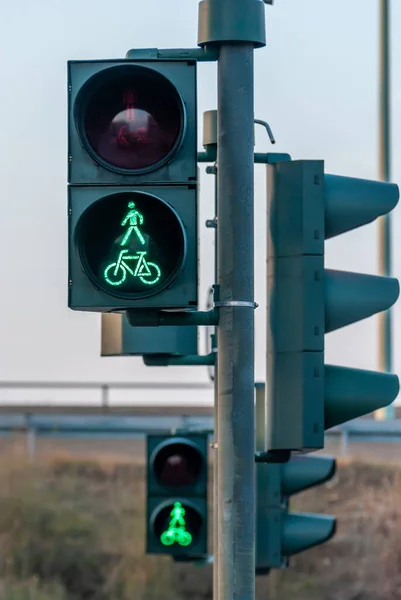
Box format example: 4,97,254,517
0,442,401,600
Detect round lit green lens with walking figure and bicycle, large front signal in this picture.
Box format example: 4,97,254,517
75,192,186,299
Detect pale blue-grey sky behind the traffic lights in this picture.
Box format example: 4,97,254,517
0,0,401,403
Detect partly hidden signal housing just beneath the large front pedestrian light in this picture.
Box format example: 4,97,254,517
101,313,198,356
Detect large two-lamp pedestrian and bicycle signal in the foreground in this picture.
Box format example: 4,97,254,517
68,59,198,312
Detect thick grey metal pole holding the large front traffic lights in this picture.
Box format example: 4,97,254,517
217,42,255,600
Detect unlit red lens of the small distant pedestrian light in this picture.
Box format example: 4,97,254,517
154,443,203,486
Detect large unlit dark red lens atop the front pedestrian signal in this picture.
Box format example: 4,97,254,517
80,65,184,172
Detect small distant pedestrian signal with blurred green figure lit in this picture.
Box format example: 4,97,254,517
146,433,208,557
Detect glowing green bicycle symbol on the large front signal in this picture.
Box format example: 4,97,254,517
104,250,161,286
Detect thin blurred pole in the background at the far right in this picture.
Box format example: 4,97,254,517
375,0,395,420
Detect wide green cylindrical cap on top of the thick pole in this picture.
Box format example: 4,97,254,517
198,0,266,48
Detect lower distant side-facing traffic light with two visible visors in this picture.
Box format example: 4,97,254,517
256,455,336,575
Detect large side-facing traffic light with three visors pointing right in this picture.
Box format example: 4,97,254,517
266,160,399,451
